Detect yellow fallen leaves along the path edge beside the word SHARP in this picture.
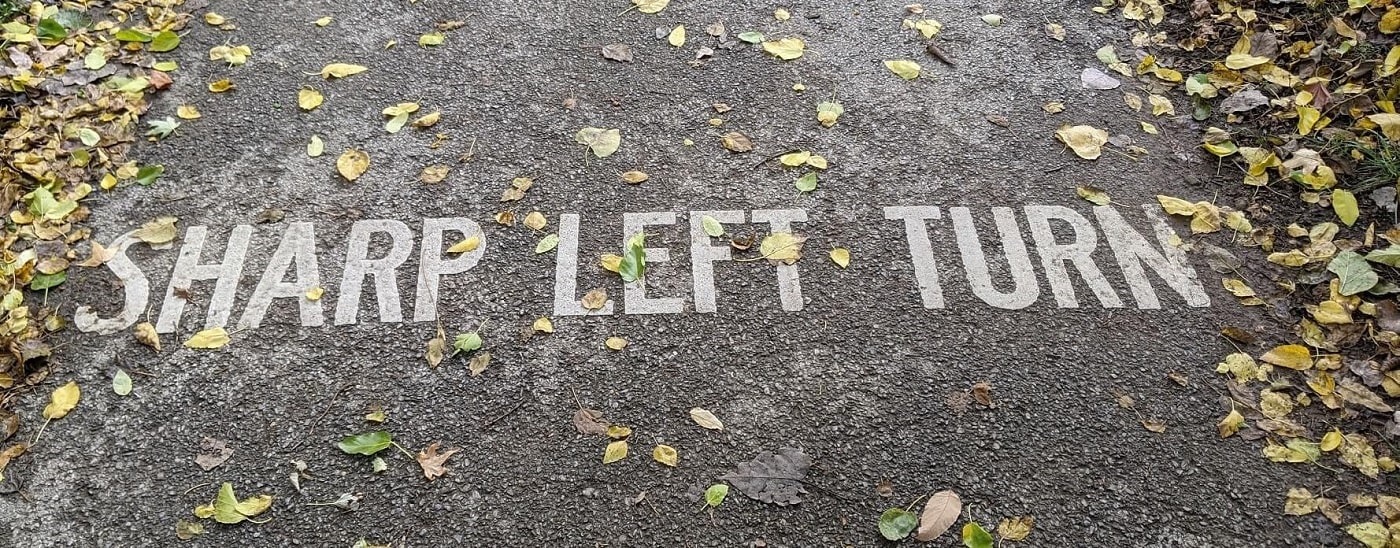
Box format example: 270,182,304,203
0,0,189,477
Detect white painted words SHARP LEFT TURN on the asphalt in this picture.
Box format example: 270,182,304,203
74,205,1210,334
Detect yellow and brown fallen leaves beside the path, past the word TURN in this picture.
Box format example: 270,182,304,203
1092,0,1400,548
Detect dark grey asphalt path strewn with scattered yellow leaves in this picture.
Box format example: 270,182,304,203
0,0,1343,547
